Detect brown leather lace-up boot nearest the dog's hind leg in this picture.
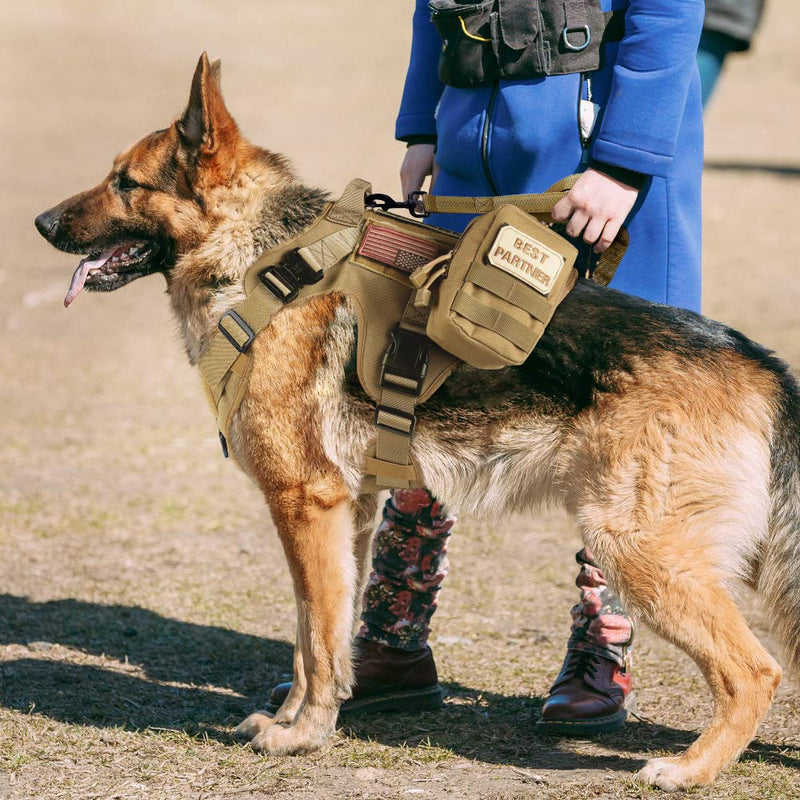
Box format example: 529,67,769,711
537,650,636,736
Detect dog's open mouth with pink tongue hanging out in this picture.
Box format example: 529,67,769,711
64,242,159,308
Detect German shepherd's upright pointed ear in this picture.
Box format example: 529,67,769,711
177,53,236,156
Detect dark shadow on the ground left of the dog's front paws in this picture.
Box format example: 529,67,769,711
0,595,293,741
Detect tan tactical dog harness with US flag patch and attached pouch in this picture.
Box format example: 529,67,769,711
199,176,627,492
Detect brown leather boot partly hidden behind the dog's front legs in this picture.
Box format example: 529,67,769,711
266,637,442,715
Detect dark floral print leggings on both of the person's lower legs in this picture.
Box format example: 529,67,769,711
359,489,633,666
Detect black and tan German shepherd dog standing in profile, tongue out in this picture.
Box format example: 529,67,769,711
36,54,800,790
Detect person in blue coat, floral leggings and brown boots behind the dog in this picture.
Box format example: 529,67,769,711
271,0,704,735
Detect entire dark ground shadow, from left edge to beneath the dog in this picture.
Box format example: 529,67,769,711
0,595,800,771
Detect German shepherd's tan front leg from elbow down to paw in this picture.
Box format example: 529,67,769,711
234,487,356,755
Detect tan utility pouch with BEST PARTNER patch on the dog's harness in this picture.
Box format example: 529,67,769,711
410,205,578,369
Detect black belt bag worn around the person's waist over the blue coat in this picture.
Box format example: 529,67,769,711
428,0,625,88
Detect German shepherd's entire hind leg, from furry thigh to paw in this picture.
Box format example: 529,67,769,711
571,368,781,790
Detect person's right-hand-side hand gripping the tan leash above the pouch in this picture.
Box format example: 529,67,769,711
552,169,639,253
